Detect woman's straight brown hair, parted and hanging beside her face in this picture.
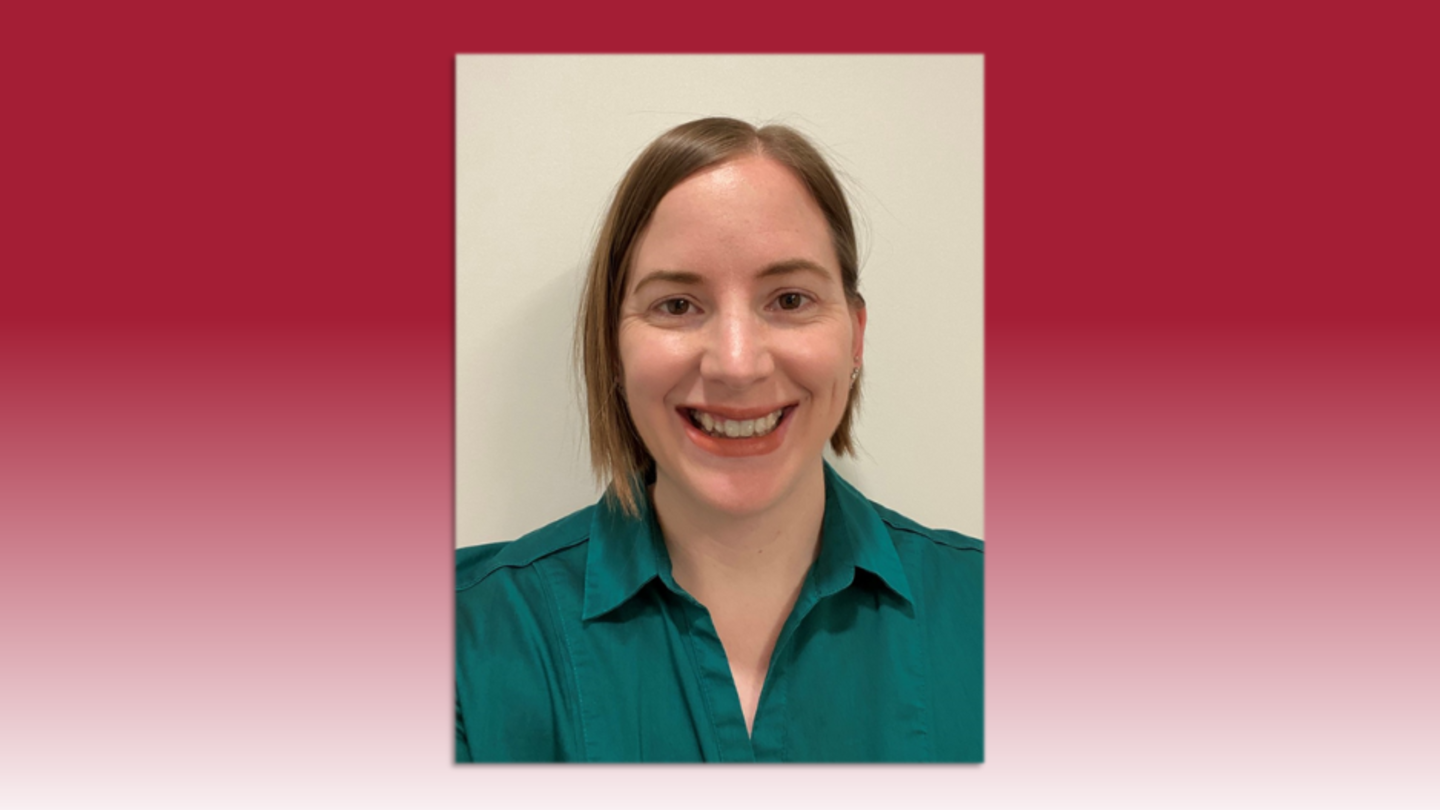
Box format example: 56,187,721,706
575,118,865,515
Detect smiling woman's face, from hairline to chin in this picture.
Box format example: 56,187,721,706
619,156,865,515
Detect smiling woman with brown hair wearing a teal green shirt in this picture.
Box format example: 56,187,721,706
456,118,982,762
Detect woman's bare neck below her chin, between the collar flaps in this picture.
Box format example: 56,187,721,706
652,464,825,608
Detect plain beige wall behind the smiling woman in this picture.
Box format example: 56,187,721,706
455,56,984,546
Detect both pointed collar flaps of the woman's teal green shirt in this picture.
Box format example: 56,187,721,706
582,461,913,621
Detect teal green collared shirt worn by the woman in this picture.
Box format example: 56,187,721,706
455,464,984,762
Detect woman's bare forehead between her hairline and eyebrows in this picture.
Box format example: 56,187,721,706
631,156,838,280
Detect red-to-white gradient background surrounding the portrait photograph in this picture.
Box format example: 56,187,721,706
0,3,1440,809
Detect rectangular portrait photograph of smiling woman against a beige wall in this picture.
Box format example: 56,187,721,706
455,55,985,762
